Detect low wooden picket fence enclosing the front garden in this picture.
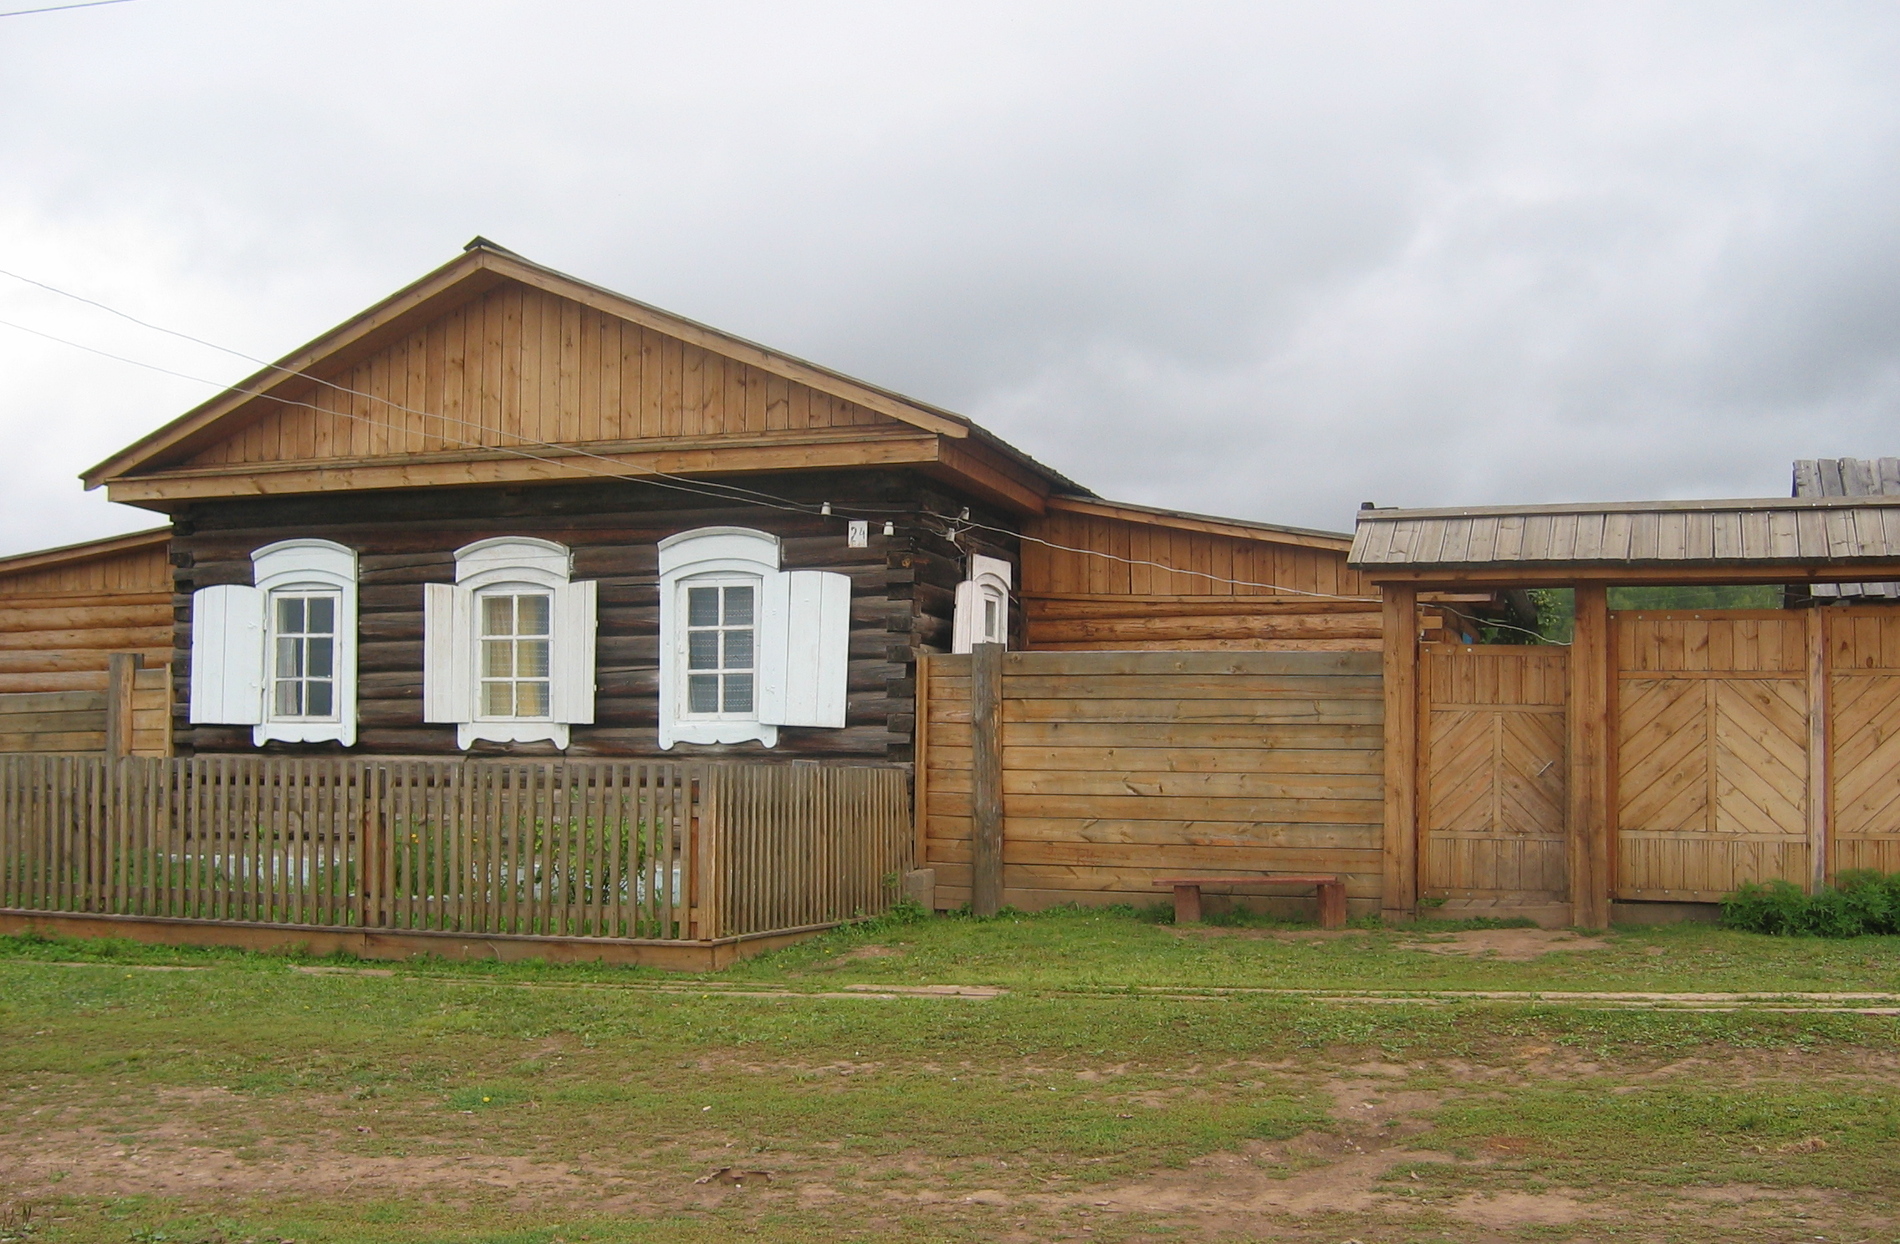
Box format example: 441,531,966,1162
0,756,910,940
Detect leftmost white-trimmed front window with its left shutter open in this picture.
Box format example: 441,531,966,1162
190,539,357,746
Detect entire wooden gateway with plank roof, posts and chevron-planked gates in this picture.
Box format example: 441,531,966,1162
1349,498,1900,927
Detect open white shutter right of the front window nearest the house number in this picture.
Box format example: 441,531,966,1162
758,570,851,729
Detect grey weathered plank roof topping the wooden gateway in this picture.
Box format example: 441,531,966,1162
1347,496,1900,581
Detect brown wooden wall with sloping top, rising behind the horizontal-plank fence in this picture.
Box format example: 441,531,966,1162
1020,511,1379,651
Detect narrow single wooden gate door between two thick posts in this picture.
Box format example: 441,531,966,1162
1419,644,1568,904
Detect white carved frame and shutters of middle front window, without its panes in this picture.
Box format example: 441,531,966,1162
422,536,599,752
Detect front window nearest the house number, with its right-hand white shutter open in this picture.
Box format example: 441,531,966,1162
659,526,851,748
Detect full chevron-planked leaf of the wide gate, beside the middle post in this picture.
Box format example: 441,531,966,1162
1611,610,1820,902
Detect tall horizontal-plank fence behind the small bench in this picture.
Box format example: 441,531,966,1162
922,651,1383,910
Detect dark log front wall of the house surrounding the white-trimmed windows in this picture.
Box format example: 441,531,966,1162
173,471,1013,763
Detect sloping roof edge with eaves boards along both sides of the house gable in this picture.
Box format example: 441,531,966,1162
80,237,1089,494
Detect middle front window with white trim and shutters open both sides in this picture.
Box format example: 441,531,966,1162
422,537,597,750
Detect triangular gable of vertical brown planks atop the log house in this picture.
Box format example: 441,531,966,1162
84,239,988,488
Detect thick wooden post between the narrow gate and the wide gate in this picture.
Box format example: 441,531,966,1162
1564,583,1611,929
